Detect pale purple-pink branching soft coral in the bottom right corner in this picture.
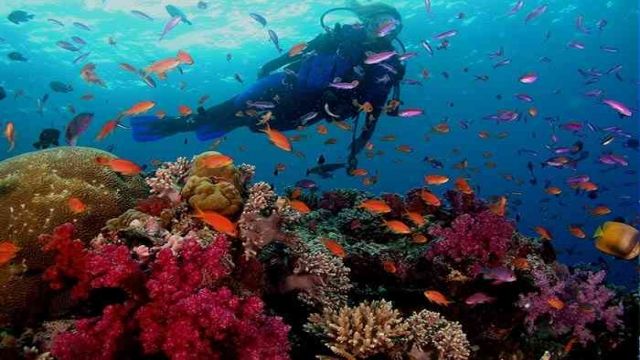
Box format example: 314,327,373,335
518,267,623,345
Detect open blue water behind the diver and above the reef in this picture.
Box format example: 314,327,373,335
0,0,639,285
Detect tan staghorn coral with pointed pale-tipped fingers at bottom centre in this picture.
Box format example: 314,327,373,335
305,300,409,359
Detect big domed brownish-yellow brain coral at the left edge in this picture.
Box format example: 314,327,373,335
0,147,148,325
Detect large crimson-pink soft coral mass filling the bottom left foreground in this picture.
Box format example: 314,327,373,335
41,224,289,360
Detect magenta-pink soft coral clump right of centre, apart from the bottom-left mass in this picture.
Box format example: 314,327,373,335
427,210,514,276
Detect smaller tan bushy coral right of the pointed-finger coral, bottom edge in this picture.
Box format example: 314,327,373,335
406,310,470,360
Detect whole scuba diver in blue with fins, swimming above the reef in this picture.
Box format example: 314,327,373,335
131,1,405,173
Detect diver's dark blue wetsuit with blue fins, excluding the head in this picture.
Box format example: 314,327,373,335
131,25,405,160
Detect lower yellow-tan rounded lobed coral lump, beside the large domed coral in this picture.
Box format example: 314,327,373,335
181,175,242,216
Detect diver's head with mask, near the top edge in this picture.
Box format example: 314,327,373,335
349,0,402,41
